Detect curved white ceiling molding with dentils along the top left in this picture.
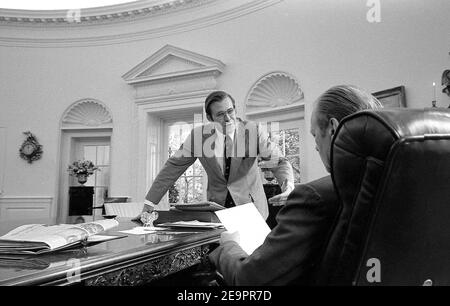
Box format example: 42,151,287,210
0,0,283,48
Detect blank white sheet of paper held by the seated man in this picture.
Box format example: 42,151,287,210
215,203,270,255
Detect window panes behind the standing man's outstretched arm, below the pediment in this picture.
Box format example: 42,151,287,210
168,123,206,203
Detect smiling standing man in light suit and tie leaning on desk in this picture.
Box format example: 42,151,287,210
141,91,294,223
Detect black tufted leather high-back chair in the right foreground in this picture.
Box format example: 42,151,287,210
316,108,450,285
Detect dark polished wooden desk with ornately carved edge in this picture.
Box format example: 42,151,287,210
0,212,223,286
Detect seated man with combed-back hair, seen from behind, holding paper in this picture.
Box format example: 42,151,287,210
209,85,381,286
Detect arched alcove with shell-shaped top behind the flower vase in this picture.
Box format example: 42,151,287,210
57,98,113,223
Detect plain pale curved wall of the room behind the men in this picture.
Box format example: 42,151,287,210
0,0,450,213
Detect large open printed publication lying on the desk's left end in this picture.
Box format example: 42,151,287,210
0,219,121,257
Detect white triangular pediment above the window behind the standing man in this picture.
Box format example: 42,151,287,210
123,45,225,84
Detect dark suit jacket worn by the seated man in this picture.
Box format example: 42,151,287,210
209,176,340,286
